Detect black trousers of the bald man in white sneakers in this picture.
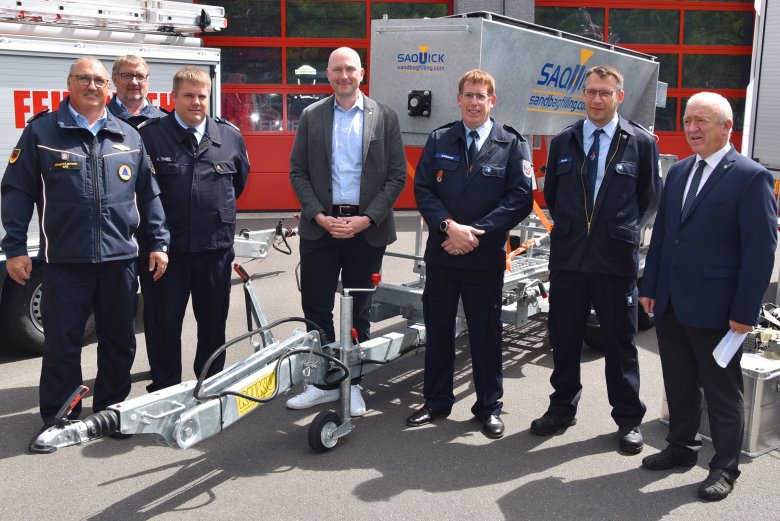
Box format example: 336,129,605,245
300,233,385,389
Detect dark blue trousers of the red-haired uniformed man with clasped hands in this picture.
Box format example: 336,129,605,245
423,264,504,420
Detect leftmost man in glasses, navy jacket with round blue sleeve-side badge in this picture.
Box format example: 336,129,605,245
0,57,170,452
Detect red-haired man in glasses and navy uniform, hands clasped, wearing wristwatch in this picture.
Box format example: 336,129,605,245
406,69,533,438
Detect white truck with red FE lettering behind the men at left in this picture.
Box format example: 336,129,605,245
0,0,227,355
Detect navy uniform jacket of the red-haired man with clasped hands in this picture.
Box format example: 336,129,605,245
414,121,533,271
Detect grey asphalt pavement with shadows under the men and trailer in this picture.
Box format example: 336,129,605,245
0,212,780,521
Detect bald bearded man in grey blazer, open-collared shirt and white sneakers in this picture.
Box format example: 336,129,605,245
287,47,406,416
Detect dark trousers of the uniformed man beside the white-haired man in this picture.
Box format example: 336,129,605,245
548,271,647,427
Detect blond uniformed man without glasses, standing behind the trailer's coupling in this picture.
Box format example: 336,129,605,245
138,67,249,392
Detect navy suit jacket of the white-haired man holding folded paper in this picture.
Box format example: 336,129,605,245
639,147,777,329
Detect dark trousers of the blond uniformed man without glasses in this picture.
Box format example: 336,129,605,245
141,247,235,392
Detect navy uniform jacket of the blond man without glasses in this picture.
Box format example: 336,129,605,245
138,114,249,253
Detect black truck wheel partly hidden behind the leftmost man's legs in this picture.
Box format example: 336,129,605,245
0,266,95,356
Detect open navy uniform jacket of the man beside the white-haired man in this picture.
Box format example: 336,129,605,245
544,117,663,277
